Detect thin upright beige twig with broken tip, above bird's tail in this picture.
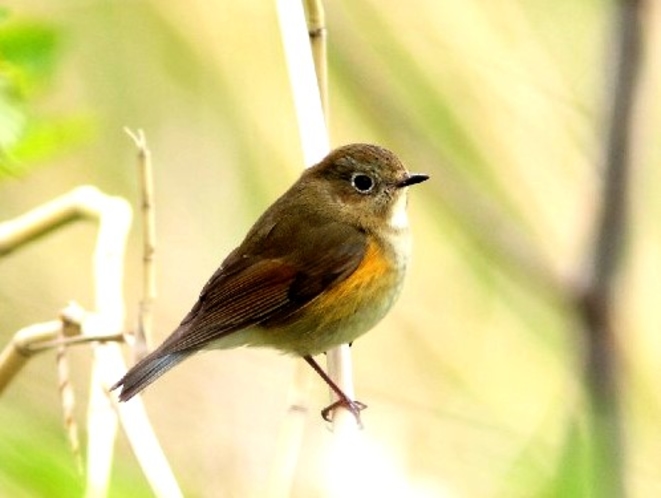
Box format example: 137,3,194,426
124,128,156,361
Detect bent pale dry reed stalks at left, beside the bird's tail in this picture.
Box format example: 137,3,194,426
0,186,182,498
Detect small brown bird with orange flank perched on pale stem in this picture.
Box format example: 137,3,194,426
112,144,429,423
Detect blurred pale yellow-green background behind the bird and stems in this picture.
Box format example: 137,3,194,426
0,0,661,497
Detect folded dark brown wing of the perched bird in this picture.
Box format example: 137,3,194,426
158,219,367,355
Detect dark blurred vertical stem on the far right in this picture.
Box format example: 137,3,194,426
580,0,641,497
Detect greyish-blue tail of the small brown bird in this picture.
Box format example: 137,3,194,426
110,349,192,401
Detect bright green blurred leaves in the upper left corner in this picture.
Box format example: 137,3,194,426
0,9,91,178
